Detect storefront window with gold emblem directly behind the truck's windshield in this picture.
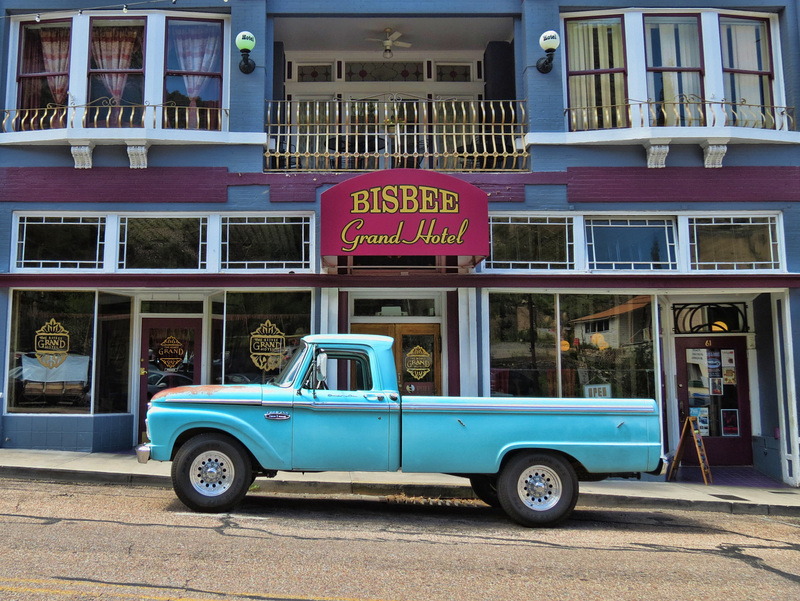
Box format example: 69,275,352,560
223,292,311,384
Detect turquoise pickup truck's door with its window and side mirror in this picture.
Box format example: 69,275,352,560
292,350,393,471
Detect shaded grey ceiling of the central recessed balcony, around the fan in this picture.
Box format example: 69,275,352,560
275,16,514,52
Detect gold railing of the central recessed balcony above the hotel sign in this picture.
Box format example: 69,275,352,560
265,99,528,171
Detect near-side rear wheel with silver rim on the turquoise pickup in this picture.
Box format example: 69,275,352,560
497,452,578,526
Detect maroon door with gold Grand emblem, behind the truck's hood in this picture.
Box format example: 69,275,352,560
137,317,203,440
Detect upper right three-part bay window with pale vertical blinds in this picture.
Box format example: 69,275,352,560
564,9,795,131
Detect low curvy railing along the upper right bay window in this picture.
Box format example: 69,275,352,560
565,95,797,131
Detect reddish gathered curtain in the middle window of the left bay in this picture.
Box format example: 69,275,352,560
92,27,141,105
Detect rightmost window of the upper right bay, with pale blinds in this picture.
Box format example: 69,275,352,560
719,17,775,127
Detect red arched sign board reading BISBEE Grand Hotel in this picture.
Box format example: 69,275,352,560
320,169,489,257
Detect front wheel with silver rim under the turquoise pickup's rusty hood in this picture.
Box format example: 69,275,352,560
172,434,253,513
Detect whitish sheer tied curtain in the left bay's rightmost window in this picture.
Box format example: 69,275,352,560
170,25,222,129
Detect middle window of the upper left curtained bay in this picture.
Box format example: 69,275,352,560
86,19,145,127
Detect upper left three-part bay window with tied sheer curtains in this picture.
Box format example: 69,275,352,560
8,10,229,132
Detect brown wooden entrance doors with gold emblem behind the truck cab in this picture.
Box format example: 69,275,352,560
350,323,442,396
